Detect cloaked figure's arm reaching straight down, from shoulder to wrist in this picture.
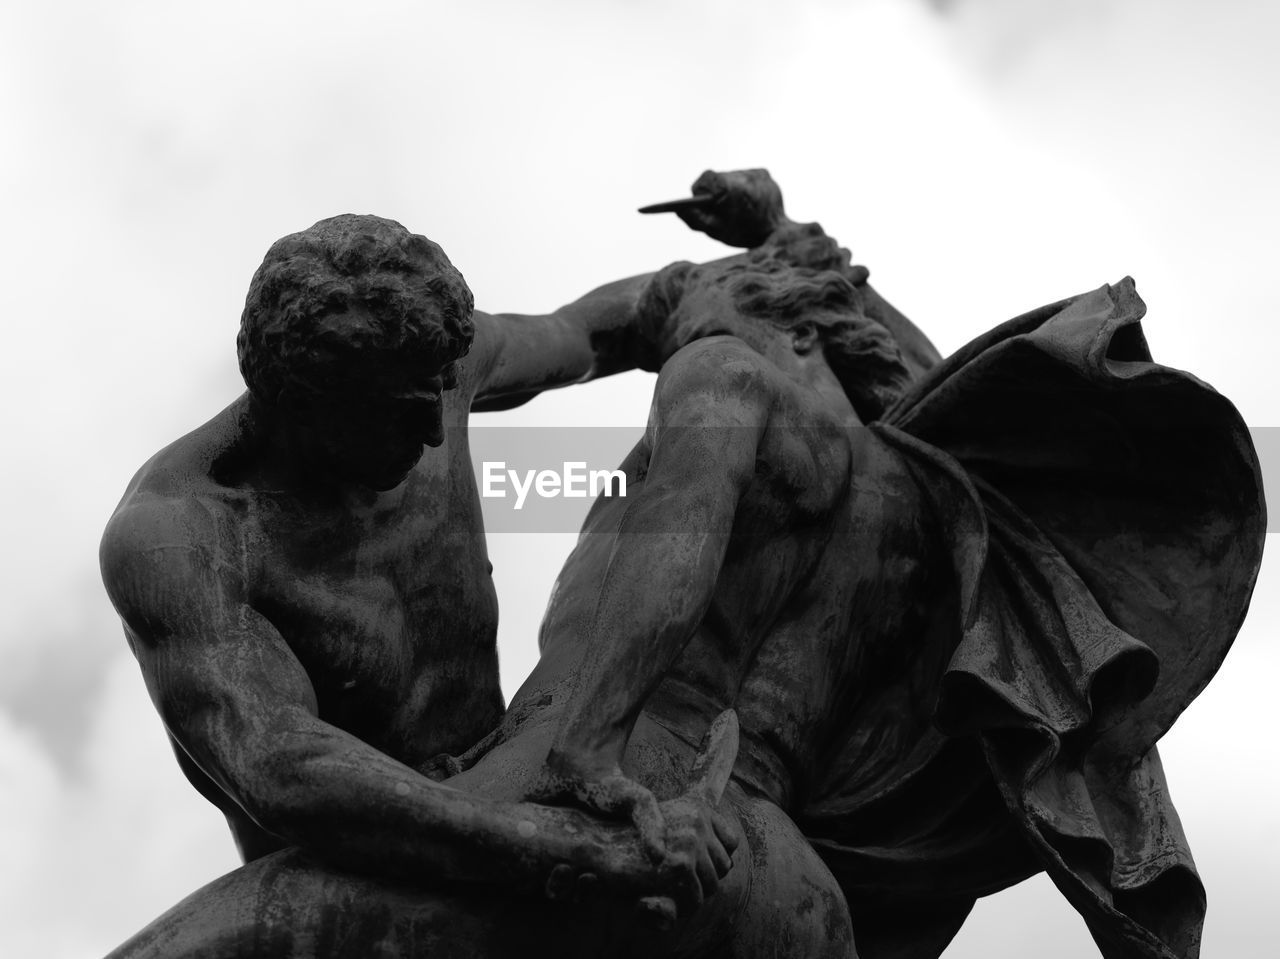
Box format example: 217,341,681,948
549,341,771,782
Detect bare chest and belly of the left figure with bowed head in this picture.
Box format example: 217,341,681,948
118,373,503,859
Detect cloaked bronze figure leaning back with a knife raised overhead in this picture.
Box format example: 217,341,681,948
97,172,1263,959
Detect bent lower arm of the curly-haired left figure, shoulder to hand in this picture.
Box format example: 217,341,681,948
101,499,670,891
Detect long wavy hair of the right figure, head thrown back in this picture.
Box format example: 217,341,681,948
639,247,911,423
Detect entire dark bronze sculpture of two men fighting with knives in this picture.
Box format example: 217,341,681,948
102,170,1265,959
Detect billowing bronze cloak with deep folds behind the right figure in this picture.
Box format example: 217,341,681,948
796,278,1266,959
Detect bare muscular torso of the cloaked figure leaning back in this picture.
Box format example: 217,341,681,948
496,337,929,807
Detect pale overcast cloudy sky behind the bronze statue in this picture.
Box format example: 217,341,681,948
0,0,1280,959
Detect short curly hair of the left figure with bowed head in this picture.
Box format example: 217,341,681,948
236,214,475,405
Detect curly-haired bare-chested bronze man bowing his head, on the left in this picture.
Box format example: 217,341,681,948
101,209,742,952
